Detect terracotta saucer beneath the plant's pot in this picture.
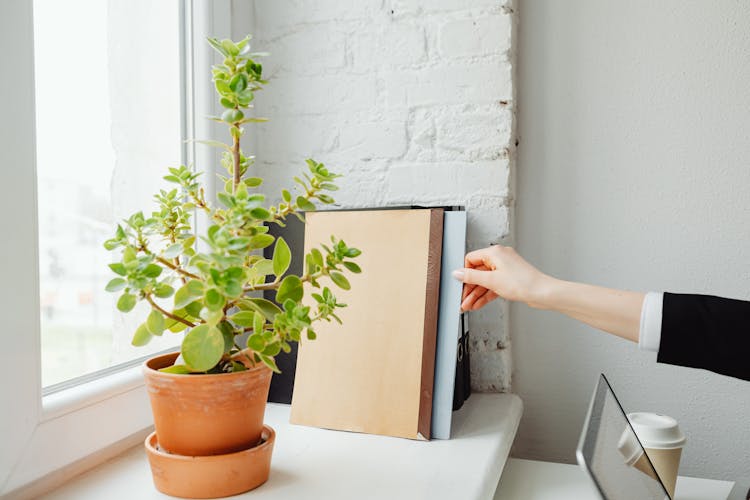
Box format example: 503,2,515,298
146,426,276,498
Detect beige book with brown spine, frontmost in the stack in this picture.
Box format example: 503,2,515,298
290,209,443,439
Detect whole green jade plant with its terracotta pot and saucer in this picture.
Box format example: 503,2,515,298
105,36,360,498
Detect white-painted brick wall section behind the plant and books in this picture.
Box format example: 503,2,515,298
241,0,515,391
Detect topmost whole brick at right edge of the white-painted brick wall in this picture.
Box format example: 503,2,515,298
440,14,512,57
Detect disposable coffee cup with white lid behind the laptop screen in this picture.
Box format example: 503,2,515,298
628,412,686,498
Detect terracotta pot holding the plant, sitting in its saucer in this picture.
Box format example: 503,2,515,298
143,353,272,456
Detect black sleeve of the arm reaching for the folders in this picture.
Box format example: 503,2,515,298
656,293,750,380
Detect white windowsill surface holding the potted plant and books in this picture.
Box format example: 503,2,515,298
43,394,522,500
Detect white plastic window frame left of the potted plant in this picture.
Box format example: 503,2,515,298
0,0,231,497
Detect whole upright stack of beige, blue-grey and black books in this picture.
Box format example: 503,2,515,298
267,208,471,439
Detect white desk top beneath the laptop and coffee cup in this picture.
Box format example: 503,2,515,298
495,458,734,500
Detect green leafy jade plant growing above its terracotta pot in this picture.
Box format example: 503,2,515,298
104,36,360,373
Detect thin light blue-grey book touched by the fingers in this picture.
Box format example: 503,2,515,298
432,210,466,439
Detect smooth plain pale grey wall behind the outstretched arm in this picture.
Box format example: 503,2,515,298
511,0,750,478
